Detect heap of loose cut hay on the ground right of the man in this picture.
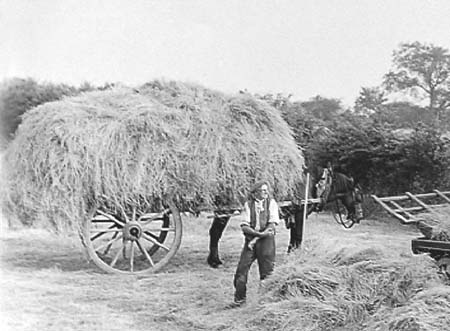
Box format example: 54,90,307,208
248,242,450,331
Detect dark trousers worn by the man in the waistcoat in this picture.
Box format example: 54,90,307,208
234,236,275,301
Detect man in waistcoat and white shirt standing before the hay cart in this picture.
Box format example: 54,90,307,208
232,181,280,307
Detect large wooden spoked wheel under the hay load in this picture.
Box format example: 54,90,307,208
83,202,182,275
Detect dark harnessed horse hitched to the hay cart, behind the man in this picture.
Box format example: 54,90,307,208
207,168,362,268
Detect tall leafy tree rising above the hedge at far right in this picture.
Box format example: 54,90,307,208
384,42,450,120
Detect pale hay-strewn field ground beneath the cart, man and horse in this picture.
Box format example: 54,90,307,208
0,214,430,331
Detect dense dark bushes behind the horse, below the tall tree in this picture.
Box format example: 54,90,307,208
281,92,450,195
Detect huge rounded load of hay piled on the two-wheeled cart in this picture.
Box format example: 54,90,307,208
3,81,304,231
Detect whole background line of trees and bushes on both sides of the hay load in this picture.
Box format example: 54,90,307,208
0,42,450,195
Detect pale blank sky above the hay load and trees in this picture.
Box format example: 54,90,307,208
0,0,450,105
